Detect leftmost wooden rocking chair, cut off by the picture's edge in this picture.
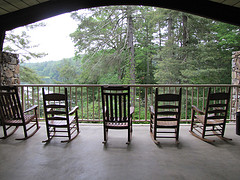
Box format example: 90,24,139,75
0,86,40,140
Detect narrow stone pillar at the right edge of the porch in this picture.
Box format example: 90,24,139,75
230,51,240,119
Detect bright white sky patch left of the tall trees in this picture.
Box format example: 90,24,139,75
6,13,77,62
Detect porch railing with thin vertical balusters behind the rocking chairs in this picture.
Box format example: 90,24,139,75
15,84,240,123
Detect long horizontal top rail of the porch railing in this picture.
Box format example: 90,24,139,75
16,84,240,87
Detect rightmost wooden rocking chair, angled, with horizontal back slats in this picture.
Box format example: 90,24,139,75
190,87,231,143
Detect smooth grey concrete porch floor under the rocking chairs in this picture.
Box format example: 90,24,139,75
0,123,240,180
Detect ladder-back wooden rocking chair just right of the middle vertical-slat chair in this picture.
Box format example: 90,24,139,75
150,88,182,144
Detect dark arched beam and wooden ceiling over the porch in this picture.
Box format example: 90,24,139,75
0,0,240,31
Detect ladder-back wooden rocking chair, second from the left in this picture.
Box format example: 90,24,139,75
42,88,80,143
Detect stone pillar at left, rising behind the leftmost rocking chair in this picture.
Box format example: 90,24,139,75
0,52,20,86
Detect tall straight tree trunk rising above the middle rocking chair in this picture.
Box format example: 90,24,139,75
127,6,136,84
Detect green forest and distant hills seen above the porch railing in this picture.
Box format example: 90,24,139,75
5,6,240,84
